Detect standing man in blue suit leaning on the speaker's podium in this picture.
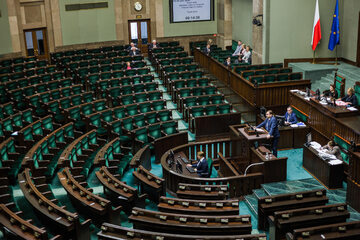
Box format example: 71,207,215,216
257,110,280,157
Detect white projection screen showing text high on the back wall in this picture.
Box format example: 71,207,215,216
169,0,214,23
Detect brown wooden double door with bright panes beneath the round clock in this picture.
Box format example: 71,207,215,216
129,19,151,53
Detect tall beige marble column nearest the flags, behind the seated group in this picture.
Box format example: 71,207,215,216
251,0,263,64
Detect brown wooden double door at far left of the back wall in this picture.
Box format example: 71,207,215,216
24,28,49,59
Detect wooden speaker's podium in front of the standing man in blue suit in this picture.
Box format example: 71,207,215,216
230,124,270,161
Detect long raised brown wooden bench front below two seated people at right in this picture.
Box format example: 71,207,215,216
290,92,360,144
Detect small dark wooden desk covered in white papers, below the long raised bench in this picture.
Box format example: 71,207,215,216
303,145,345,189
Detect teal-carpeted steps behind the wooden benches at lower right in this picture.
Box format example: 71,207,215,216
245,178,360,221
